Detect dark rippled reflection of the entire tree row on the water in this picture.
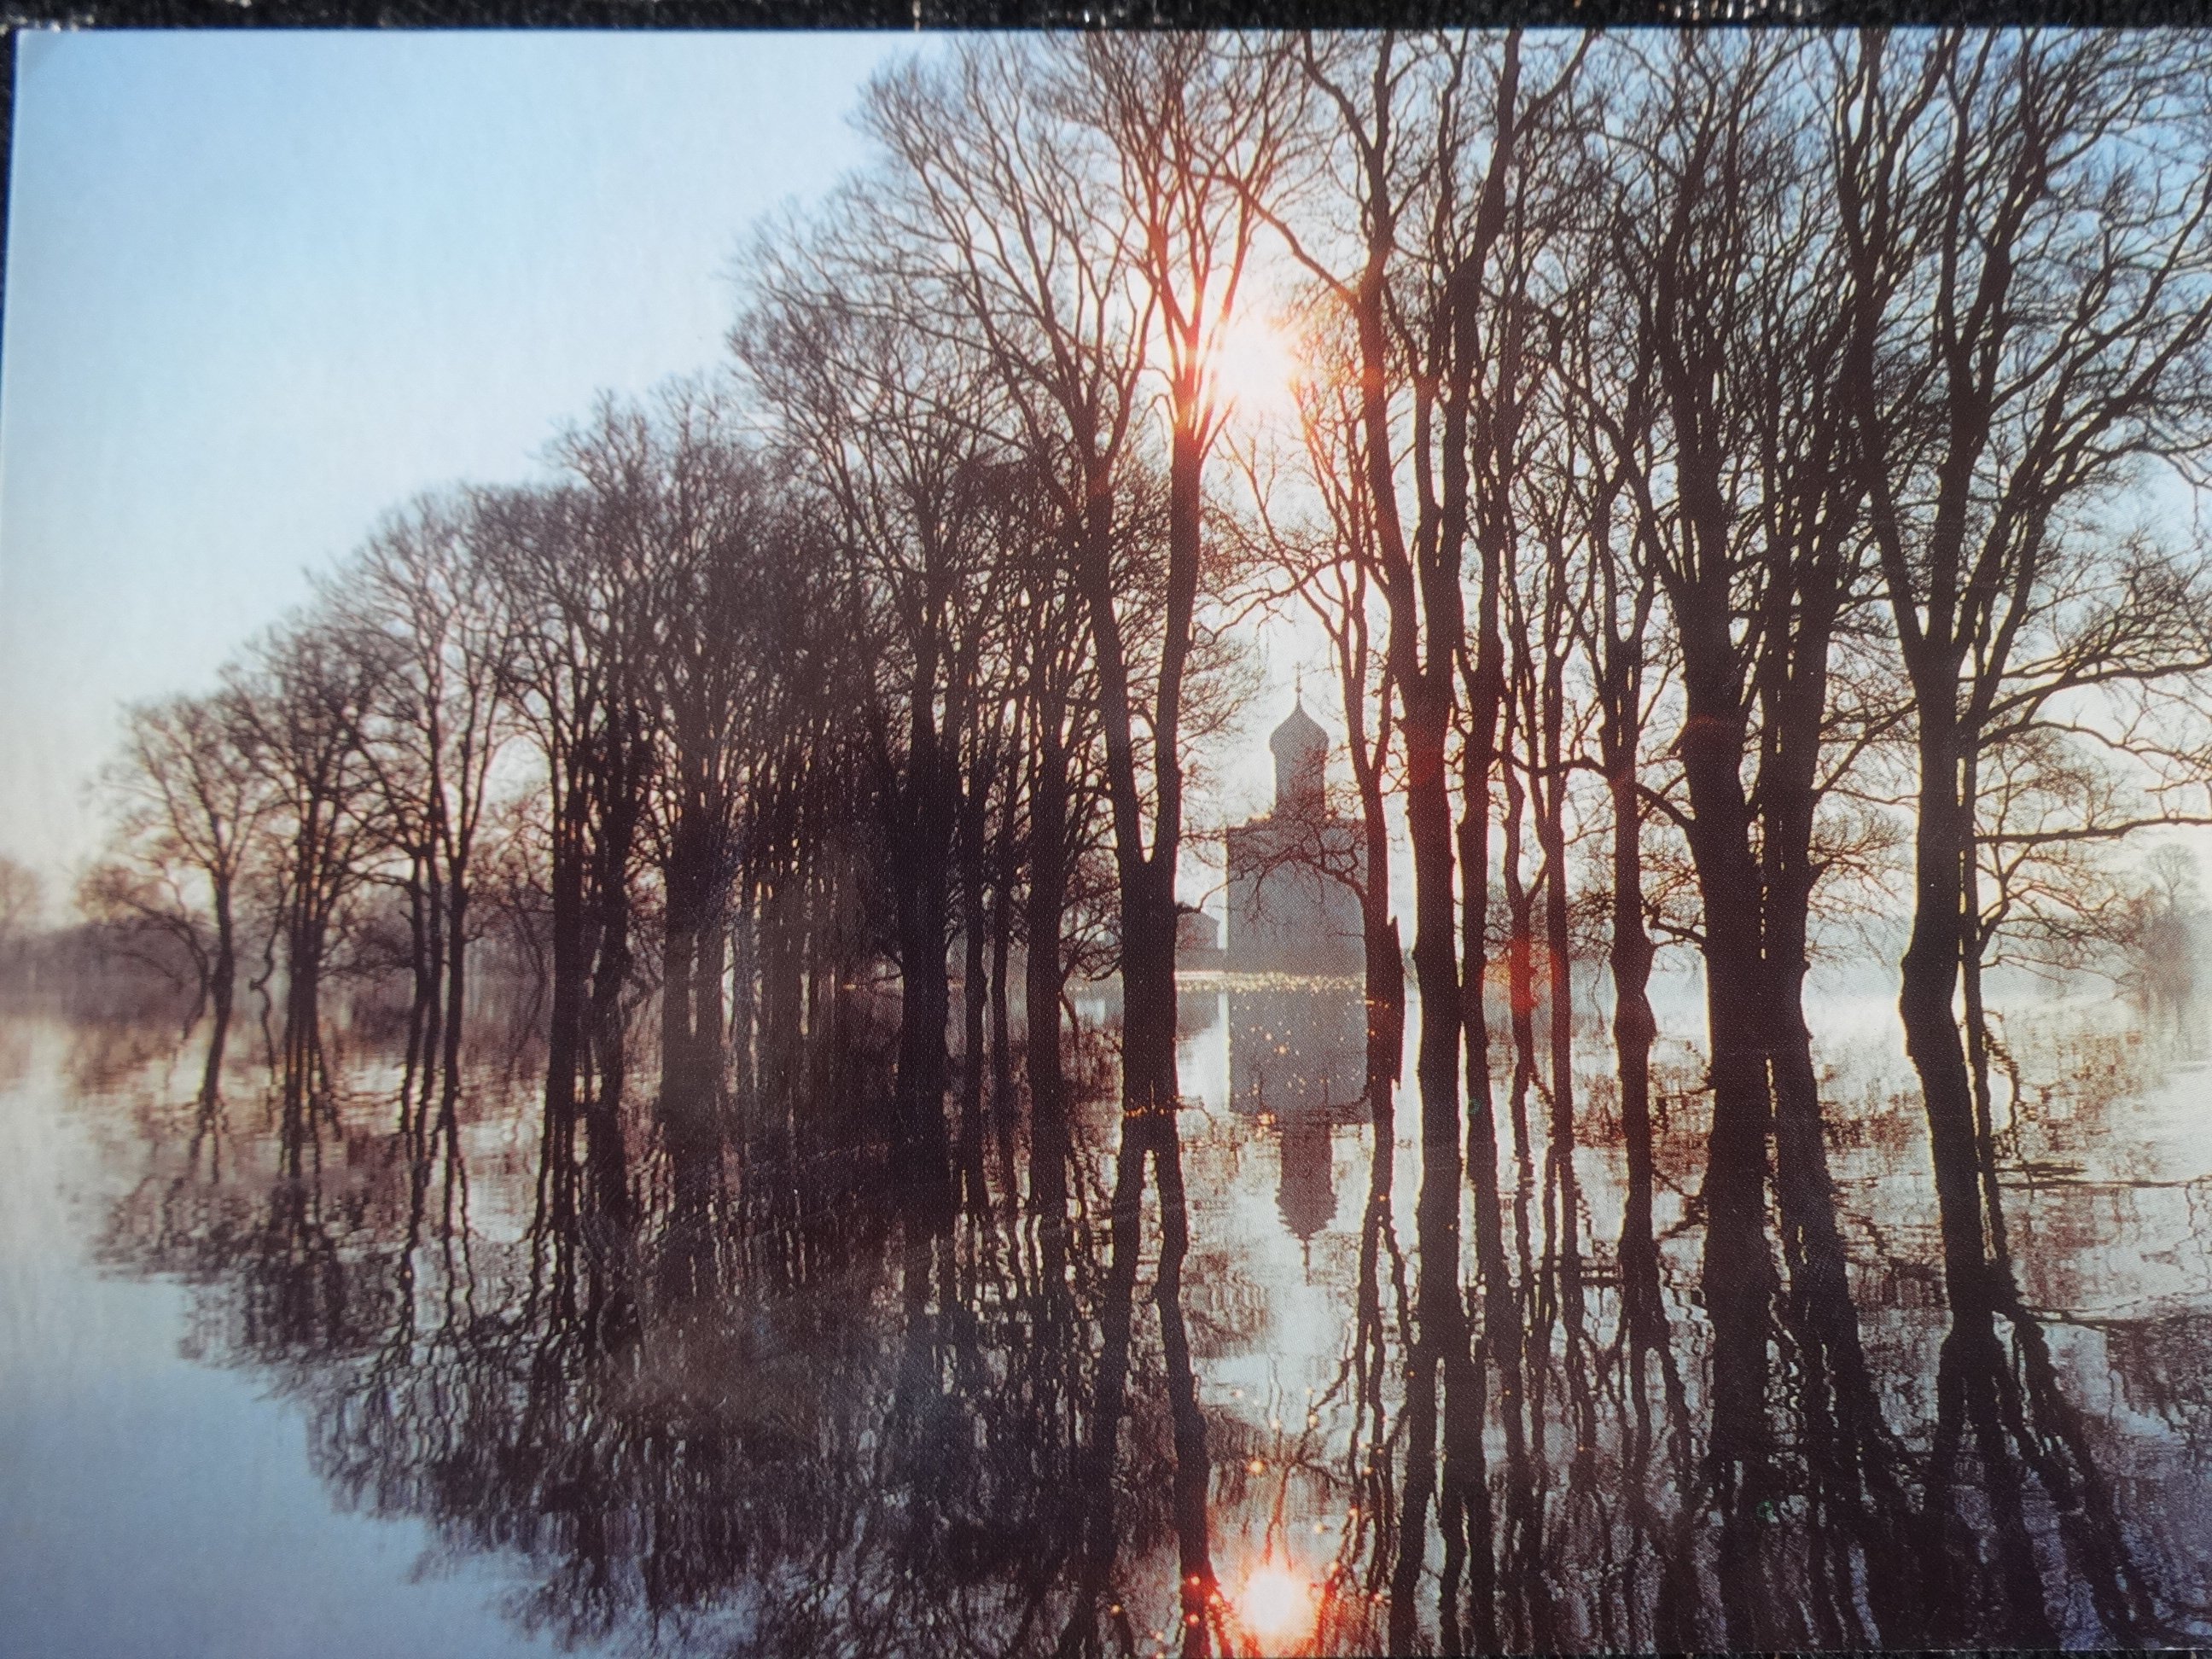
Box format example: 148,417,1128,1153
75,973,2208,1655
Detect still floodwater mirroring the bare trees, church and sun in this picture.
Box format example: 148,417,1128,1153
0,975,2212,1655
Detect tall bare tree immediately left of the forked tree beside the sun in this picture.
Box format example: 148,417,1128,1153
849,44,1159,1219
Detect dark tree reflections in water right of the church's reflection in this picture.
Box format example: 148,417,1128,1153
1291,981,2186,1650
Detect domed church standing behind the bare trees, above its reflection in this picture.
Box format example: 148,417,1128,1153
1225,692,1367,975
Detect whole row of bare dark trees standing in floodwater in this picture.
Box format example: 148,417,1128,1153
89,31,2212,1469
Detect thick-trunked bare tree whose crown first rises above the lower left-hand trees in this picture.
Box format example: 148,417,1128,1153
736,190,1013,1203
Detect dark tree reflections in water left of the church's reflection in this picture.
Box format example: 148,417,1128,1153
95,1013,1247,1652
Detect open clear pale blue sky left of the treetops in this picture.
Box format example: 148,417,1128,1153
0,31,927,898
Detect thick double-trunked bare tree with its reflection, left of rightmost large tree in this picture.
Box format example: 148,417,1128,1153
1610,38,1929,1641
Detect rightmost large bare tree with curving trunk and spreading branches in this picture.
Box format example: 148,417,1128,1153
1838,19,2212,1299
